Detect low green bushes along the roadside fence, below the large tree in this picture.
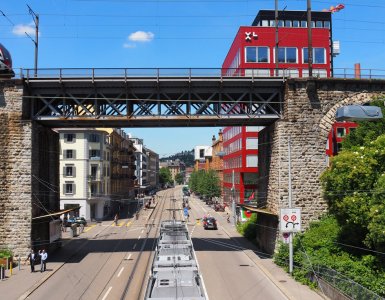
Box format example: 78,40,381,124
274,216,385,297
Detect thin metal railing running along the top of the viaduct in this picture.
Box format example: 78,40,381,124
15,68,385,80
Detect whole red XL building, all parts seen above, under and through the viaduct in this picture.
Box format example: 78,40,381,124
222,10,350,216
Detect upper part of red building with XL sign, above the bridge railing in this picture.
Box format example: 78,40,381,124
222,10,337,77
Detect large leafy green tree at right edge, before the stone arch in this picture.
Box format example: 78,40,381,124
321,134,385,251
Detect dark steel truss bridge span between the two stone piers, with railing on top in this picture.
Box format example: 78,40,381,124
22,69,285,127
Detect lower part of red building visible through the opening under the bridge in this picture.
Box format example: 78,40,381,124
223,126,262,204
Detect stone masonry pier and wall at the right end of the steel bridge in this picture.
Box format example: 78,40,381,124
267,79,385,228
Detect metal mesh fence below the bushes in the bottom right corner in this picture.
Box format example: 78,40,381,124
313,266,385,300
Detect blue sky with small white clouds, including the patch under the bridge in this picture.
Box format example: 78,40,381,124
0,0,385,157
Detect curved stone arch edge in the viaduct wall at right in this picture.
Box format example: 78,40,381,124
319,93,385,140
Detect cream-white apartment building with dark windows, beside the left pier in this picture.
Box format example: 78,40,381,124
57,129,111,220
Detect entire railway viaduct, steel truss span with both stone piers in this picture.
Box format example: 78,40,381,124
0,72,385,256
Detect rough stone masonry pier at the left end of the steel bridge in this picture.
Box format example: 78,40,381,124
0,80,32,256
